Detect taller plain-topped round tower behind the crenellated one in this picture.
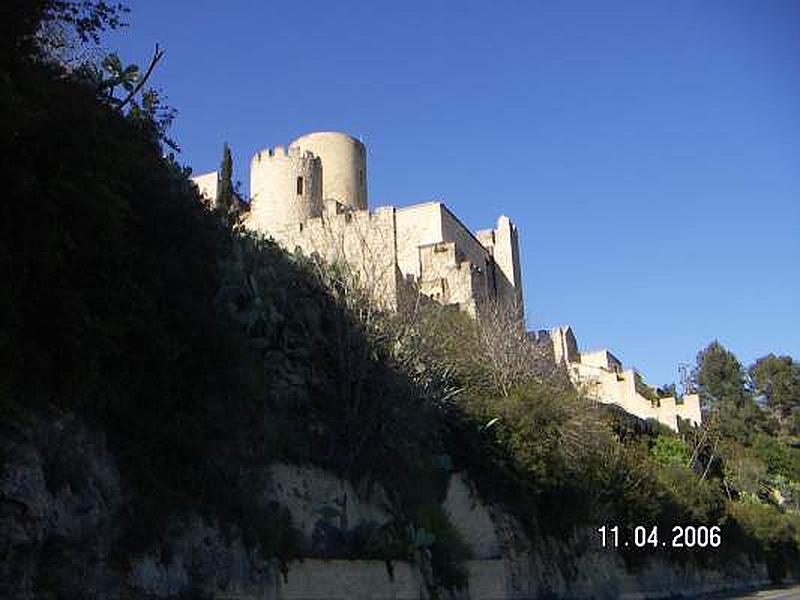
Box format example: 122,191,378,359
289,131,367,210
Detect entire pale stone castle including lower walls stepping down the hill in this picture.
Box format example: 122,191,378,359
193,131,700,429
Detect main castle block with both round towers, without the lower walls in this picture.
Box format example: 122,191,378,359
245,131,522,315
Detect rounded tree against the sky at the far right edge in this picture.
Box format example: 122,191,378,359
749,354,800,430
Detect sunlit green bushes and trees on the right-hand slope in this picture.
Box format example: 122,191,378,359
384,292,800,578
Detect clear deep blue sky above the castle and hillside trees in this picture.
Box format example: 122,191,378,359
114,0,800,383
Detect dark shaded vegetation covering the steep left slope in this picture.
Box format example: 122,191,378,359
0,2,447,584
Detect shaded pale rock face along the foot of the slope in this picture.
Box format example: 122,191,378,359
0,415,767,600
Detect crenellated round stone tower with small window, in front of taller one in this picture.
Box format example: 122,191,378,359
248,146,322,233
